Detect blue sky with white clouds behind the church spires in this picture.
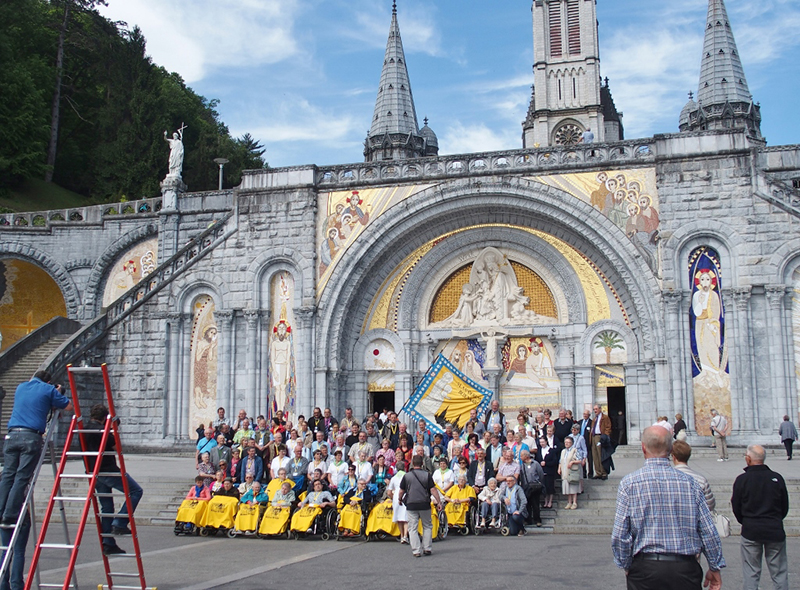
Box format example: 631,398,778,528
102,0,800,166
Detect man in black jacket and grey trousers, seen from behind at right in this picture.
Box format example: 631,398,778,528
731,445,789,590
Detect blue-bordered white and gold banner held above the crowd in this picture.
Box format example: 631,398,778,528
402,354,494,432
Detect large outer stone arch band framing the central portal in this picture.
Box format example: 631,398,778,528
316,178,664,408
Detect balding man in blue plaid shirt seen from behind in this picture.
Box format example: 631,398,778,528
611,426,725,590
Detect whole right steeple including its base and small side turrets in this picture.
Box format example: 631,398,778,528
679,0,762,139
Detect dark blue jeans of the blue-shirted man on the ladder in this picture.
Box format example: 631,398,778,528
0,430,43,522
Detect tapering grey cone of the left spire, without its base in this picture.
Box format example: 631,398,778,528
369,2,419,137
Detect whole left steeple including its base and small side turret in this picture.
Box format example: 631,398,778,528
364,1,439,162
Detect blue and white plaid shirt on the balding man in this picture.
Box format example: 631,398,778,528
611,458,725,571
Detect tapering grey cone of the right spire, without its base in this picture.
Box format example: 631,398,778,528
697,0,753,105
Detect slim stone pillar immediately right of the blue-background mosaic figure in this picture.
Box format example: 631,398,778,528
725,287,760,432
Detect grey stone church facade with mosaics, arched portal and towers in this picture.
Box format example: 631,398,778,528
0,0,800,447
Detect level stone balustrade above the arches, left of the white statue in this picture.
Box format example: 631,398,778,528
0,197,161,231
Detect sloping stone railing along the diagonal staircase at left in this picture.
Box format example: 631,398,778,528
40,211,237,378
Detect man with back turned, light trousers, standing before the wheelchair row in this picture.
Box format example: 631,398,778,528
400,455,442,557
